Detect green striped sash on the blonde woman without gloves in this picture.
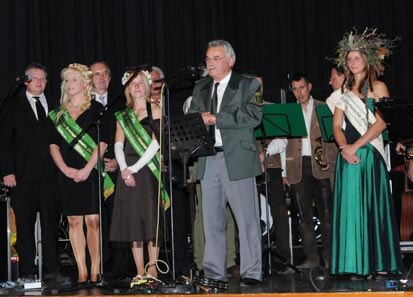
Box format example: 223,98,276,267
49,109,115,200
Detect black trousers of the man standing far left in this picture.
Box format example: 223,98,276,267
11,181,60,277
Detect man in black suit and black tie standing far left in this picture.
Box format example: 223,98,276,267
0,63,68,283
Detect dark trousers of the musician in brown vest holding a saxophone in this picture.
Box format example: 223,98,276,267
292,156,332,261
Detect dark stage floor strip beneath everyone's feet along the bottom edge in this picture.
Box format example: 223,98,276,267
0,268,413,297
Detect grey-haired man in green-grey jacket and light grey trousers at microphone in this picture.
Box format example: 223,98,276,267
189,40,262,286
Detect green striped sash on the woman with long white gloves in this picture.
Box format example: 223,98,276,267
115,108,171,211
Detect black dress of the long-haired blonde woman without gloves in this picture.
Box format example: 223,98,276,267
50,100,107,216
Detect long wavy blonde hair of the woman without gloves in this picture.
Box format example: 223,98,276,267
58,63,93,117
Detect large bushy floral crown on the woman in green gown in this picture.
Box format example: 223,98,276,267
334,28,401,73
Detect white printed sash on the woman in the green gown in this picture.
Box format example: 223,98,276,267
327,89,386,160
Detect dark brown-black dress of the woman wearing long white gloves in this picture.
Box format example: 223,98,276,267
110,114,163,241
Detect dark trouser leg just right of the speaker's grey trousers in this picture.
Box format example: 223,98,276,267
267,168,291,262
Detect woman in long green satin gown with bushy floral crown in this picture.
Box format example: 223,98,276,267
327,31,402,278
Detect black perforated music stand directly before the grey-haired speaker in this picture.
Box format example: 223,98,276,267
165,113,215,185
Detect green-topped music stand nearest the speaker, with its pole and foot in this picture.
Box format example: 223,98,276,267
255,103,307,275
